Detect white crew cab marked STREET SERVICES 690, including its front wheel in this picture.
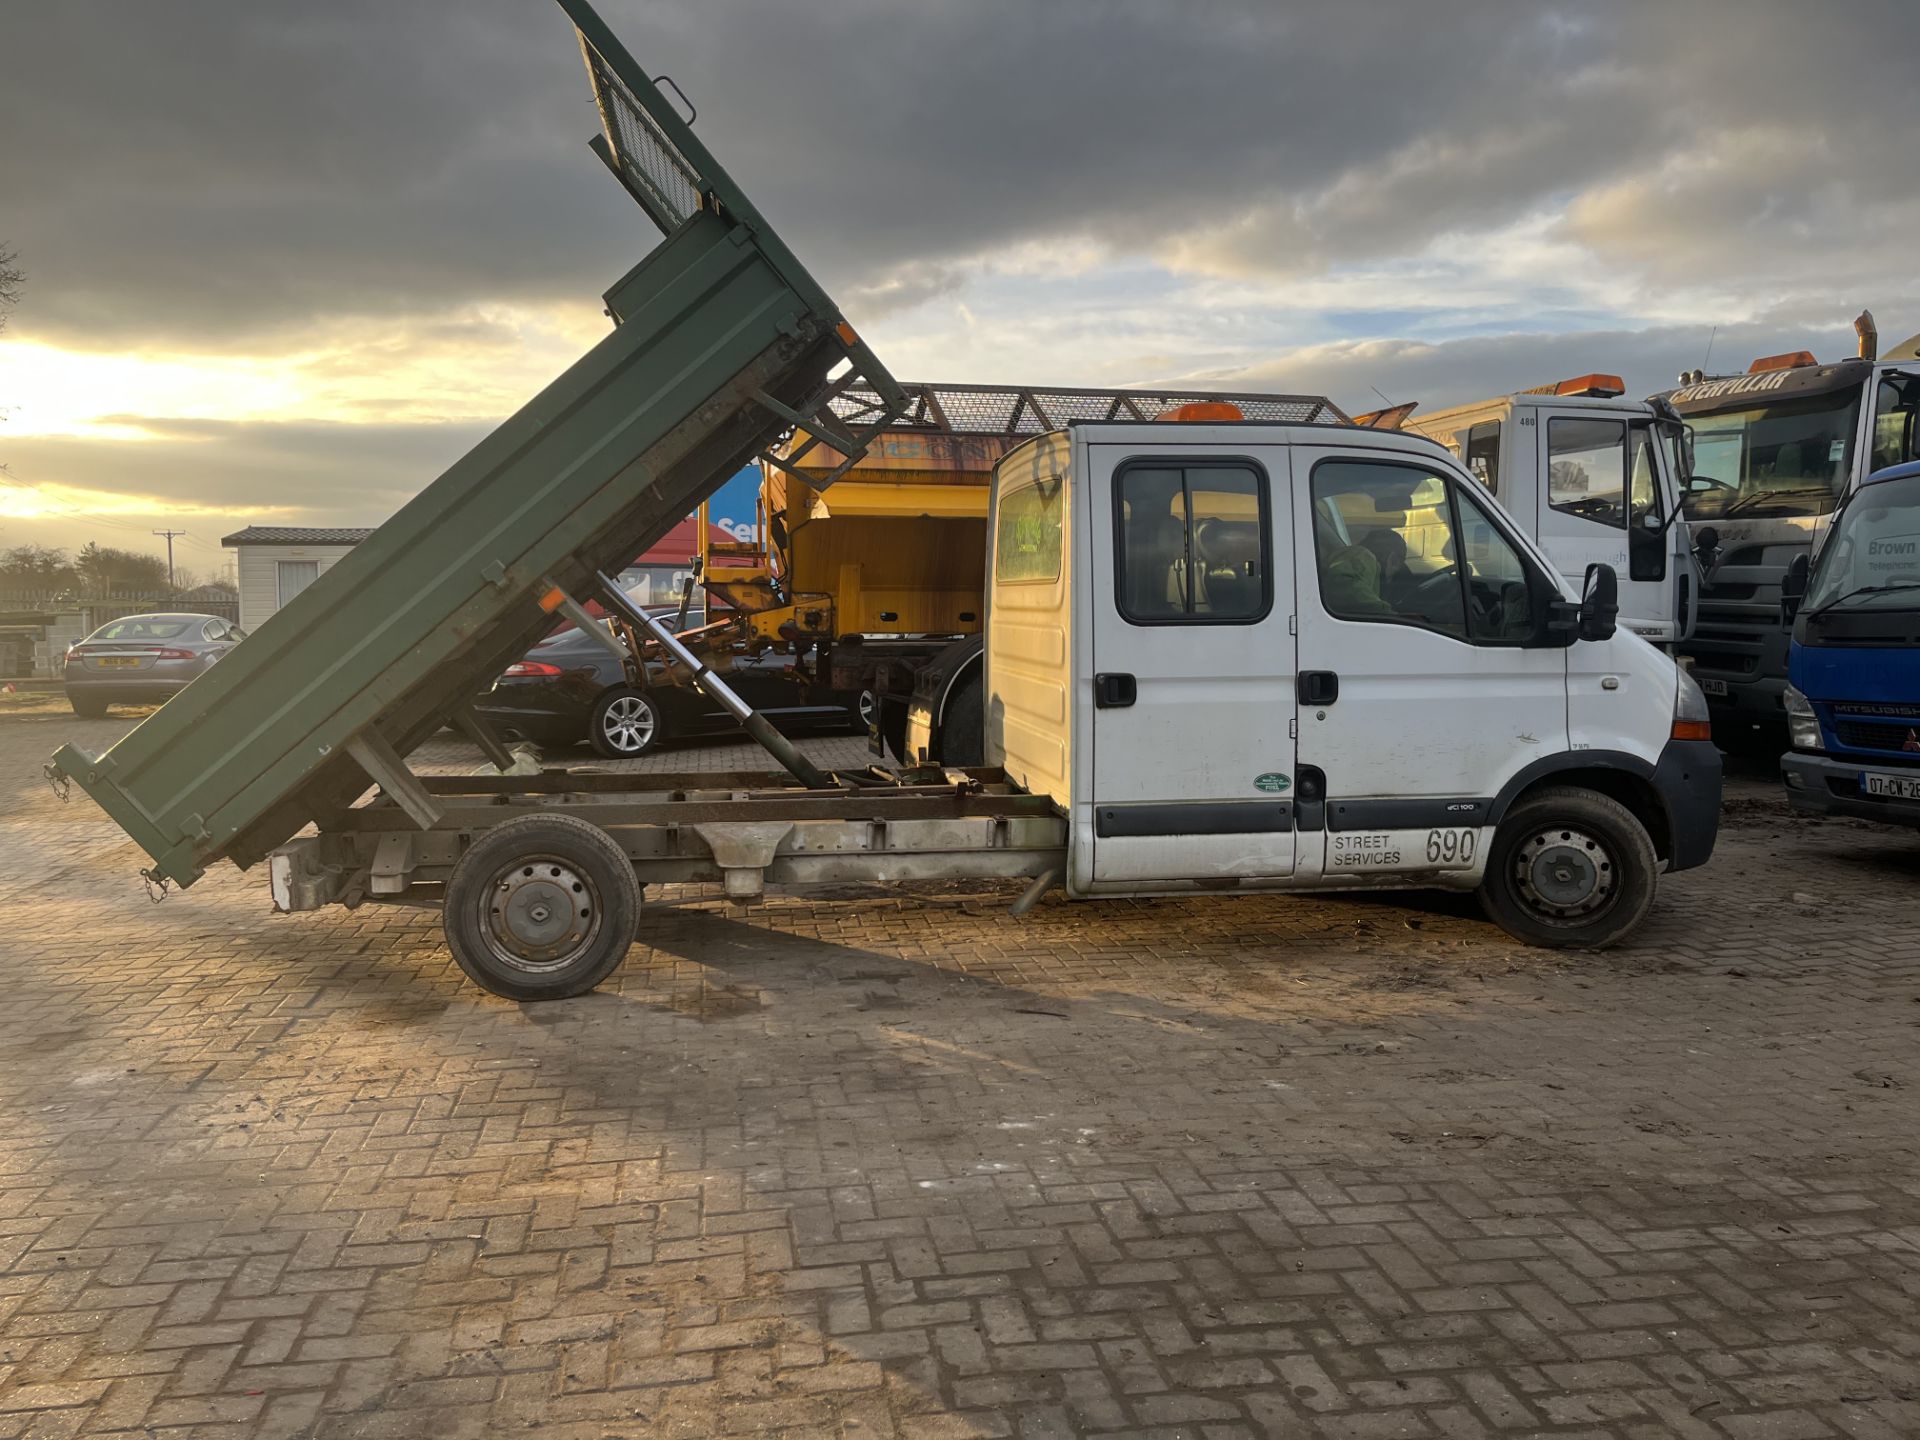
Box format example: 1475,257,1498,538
983,420,1720,945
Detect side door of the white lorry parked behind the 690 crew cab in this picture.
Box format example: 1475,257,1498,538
1534,409,1684,645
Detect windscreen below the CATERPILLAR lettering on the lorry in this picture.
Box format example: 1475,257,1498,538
1686,384,1860,520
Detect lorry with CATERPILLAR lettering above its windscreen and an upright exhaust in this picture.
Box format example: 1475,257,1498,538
1651,311,1920,751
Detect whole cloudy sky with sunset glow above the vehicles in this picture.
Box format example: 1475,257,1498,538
0,0,1920,570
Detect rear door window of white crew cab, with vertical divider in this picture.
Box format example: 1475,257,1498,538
1114,461,1273,624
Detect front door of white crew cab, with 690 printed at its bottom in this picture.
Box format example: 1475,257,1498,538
1292,445,1567,877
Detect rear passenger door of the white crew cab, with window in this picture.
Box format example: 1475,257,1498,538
1079,444,1294,889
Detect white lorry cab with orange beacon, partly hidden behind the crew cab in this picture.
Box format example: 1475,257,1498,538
1402,374,1701,647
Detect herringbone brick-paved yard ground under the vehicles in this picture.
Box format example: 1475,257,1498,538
0,714,1920,1440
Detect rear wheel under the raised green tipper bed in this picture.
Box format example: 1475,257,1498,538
442,814,639,1000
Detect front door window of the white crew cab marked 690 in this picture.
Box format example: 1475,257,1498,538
1313,461,1534,645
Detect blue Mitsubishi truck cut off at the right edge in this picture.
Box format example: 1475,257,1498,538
1780,463,1920,826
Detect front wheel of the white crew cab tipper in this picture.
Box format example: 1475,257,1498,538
1480,787,1659,950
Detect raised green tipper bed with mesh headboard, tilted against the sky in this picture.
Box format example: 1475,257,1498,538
54,0,902,885
